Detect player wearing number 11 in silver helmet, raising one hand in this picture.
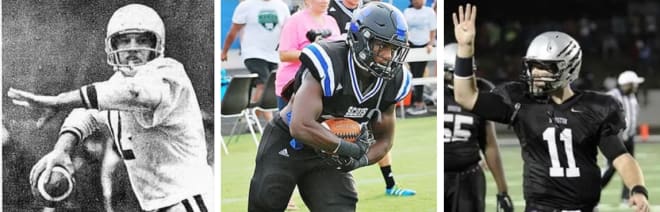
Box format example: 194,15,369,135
452,4,649,211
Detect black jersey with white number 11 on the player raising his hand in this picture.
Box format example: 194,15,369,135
473,82,625,209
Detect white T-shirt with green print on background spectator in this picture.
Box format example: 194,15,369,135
232,0,291,63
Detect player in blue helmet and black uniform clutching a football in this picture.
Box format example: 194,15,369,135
248,3,412,211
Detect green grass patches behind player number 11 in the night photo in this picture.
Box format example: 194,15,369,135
485,143,660,212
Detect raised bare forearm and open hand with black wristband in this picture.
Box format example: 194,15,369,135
452,4,478,110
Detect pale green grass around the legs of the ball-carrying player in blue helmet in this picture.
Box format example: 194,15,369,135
221,117,437,212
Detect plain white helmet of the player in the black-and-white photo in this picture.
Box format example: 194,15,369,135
105,4,165,70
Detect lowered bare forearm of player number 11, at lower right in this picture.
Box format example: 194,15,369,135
613,153,650,212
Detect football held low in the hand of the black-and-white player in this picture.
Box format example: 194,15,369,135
36,166,74,201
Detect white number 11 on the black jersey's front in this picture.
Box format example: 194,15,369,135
543,127,580,177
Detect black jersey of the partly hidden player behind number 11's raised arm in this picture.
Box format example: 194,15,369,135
444,78,493,172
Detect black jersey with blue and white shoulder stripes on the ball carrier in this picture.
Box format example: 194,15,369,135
295,41,412,123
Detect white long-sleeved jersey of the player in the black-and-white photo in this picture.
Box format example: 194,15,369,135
61,58,213,211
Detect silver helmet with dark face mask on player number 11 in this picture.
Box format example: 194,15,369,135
522,31,582,96
